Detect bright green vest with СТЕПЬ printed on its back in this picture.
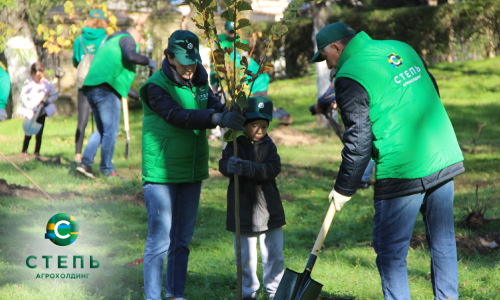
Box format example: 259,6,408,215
335,32,464,179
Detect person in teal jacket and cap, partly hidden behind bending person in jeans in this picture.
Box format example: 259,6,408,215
72,9,108,163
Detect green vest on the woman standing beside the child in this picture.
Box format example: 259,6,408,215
139,70,209,183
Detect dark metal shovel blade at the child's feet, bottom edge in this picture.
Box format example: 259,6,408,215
274,268,323,300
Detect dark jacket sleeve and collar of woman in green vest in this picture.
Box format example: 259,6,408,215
144,58,225,129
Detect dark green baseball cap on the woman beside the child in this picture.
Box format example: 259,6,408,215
168,30,201,66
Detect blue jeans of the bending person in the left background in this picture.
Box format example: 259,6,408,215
82,88,122,175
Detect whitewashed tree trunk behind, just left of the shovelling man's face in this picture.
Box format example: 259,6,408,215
309,1,331,127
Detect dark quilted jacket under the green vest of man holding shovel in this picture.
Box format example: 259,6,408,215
334,60,465,200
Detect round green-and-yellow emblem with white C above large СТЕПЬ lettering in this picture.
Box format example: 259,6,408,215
45,213,80,246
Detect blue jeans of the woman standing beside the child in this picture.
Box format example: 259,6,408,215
144,181,201,300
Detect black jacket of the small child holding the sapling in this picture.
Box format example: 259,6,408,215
219,135,286,232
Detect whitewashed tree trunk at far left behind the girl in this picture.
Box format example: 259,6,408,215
0,0,38,118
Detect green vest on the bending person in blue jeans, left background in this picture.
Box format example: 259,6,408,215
82,34,139,98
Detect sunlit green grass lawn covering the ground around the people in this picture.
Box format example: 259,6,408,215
0,55,500,300
